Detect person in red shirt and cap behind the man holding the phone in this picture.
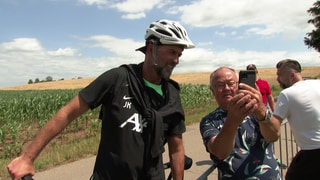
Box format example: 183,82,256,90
247,64,276,111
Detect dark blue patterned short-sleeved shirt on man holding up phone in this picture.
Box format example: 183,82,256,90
200,108,281,180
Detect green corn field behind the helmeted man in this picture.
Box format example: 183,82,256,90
0,84,212,163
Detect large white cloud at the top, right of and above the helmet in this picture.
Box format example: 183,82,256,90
175,0,314,35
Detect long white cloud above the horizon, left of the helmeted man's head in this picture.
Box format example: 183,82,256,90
0,35,144,86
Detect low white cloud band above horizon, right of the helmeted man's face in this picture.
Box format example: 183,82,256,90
174,47,319,73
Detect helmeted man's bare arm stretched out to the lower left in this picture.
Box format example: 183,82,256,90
7,95,89,180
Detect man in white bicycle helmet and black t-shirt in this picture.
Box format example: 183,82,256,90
8,20,194,180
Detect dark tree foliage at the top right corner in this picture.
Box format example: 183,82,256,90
304,0,320,52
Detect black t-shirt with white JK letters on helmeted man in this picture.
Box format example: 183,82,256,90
79,64,186,180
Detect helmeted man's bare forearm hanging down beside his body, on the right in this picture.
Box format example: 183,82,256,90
168,135,185,180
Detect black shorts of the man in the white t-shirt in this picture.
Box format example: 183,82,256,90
285,149,320,180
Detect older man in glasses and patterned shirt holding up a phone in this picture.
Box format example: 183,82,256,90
200,67,281,180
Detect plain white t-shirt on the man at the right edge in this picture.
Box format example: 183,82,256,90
274,80,320,150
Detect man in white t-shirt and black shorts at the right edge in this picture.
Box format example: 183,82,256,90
273,59,320,180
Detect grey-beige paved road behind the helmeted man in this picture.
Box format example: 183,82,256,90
34,123,217,180
